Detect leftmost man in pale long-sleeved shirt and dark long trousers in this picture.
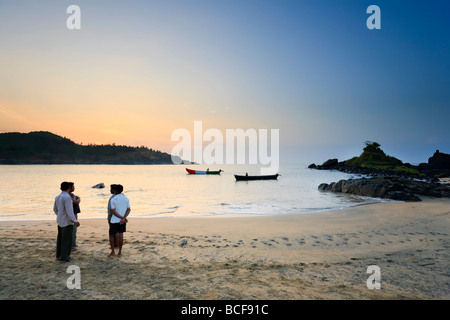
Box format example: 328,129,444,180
53,181,80,262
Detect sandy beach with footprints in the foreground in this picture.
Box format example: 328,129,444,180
0,199,450,300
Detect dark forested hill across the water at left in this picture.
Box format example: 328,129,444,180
0,131,176,164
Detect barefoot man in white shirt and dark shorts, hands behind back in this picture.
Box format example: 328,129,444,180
109,184,131,257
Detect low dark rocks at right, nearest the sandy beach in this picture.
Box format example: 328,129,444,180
318,176,450,201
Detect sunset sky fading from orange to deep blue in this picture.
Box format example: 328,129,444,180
0,0,450,164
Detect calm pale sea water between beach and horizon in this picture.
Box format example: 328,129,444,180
0,165,384,220
